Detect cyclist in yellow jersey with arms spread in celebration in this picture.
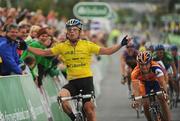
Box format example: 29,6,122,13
20,19,130,121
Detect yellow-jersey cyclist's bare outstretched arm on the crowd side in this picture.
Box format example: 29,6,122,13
28,47,53,56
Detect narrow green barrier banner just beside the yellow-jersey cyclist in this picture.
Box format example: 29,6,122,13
43,76,70,121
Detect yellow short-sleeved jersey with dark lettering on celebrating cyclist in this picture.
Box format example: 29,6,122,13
51,40,100,80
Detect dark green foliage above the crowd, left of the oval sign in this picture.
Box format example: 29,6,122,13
0,0,83,18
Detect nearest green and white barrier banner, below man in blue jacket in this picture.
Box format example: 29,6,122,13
0,75,48,121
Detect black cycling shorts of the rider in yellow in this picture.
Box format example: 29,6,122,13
63,77,94,103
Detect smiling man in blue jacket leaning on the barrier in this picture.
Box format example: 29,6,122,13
0,24,22,75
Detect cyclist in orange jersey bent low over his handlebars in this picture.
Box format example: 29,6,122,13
131,51,171,121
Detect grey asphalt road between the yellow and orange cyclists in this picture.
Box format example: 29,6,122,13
96,53,180,121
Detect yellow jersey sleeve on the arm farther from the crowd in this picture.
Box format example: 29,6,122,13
88,41,101,54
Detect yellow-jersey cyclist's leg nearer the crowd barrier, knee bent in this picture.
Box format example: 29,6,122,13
59,83,76,121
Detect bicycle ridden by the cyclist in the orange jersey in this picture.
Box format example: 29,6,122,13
134,91,165,121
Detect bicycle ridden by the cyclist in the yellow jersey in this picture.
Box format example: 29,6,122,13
57,90,95,121
